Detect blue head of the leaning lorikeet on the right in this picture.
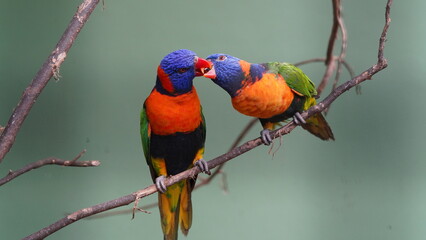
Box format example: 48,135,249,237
204,53,263,97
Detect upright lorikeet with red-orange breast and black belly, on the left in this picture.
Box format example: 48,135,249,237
140,49,210,240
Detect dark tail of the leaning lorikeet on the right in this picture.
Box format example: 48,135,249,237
302,98,334,140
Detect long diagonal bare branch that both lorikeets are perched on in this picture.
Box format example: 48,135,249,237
24,0,392,237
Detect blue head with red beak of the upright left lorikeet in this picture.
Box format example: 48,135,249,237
156,49,210,95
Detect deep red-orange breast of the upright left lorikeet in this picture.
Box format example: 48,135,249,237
145,87,202,135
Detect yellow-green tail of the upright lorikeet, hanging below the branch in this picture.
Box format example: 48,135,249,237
158,180,192,240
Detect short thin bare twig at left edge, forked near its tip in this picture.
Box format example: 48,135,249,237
0,150,101,186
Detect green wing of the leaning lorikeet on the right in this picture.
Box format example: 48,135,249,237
265,62,317,97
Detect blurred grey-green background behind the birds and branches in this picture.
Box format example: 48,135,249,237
0,0,426,240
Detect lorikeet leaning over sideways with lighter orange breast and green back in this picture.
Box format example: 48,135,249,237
204,54,334,145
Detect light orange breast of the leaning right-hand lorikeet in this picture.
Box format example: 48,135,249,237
232,73,294,118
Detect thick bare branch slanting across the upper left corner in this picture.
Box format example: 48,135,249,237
0,0,99,163
